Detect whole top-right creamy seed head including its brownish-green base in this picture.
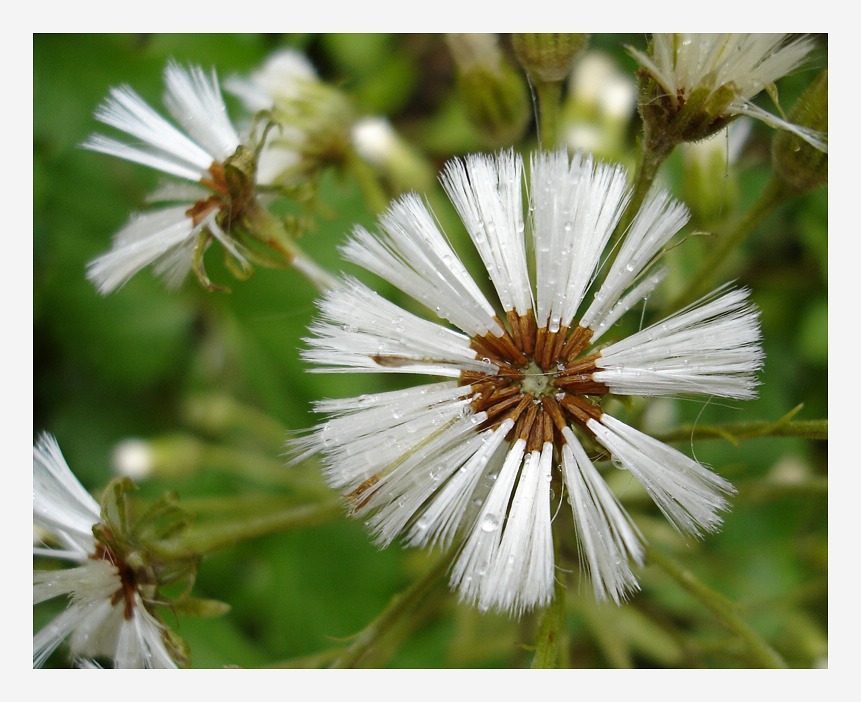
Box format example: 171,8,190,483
629,34,828,151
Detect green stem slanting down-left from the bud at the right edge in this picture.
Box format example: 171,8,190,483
669,178,790,309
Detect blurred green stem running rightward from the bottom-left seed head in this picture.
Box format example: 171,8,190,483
156,500,343,558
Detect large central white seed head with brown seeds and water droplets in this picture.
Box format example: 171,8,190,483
293,152,762,614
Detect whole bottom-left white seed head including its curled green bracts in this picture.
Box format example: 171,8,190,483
33,434,195,668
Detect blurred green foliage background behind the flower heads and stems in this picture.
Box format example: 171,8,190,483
33,34,828,667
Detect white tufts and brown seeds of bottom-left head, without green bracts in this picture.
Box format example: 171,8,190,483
33,435,177,668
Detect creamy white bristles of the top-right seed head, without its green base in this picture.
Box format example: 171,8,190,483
629,34,828,151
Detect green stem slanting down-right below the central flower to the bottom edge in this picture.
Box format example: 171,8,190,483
646,547,787,668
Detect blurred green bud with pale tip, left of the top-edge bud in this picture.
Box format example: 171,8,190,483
447,34,532,146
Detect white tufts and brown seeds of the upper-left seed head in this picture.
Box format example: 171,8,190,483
83,62,250,294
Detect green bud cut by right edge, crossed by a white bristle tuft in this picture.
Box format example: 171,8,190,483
771,70,828,193
